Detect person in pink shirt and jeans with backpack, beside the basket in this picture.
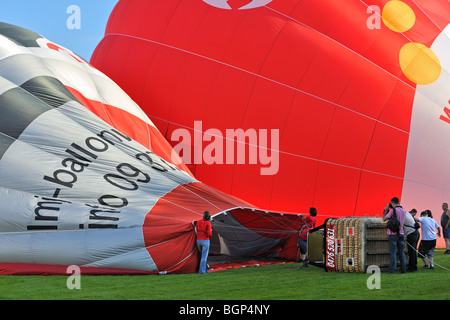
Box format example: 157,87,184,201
383,197,406,273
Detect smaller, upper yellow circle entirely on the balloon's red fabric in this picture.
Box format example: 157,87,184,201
381,1,416,32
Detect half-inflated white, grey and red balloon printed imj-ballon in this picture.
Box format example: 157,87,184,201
0,23,304,274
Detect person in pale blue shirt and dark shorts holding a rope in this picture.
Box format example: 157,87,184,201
414,211,441,269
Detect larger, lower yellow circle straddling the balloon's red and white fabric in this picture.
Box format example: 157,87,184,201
400,43,441,85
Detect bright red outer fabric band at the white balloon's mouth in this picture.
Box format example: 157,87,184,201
143,182,249,273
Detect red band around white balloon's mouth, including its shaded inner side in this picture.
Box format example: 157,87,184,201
143,182,303,273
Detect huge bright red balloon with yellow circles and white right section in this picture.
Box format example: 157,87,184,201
91,0,450,248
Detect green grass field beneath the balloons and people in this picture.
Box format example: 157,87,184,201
0,250,450,300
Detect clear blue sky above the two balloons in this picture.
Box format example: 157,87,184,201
0,0,118,61
